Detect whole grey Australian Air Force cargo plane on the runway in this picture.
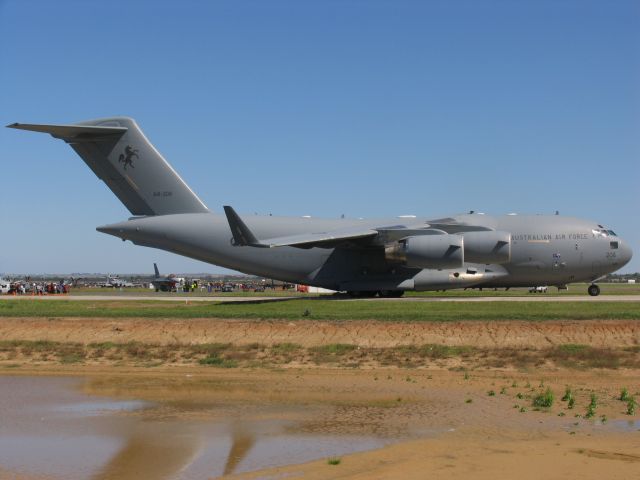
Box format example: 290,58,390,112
9,117,632,297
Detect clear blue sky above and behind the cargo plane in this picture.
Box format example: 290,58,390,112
0,0,640,273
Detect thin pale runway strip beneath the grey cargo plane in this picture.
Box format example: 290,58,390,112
0,295,640,303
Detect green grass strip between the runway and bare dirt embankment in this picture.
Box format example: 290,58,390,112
0,299,640,322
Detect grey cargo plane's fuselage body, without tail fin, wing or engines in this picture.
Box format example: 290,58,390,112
98,213,631,291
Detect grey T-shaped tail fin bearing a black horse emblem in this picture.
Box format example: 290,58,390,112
8,117,208,215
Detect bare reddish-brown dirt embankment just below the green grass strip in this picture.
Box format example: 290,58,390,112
0,317,640,348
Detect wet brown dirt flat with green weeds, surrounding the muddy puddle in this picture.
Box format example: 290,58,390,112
0,365,640,480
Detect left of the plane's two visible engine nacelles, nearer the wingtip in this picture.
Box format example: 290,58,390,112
385,234,465,268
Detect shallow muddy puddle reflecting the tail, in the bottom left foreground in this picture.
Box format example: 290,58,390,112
0,376,410,480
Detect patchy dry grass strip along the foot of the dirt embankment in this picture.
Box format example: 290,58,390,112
0,340,640,370
